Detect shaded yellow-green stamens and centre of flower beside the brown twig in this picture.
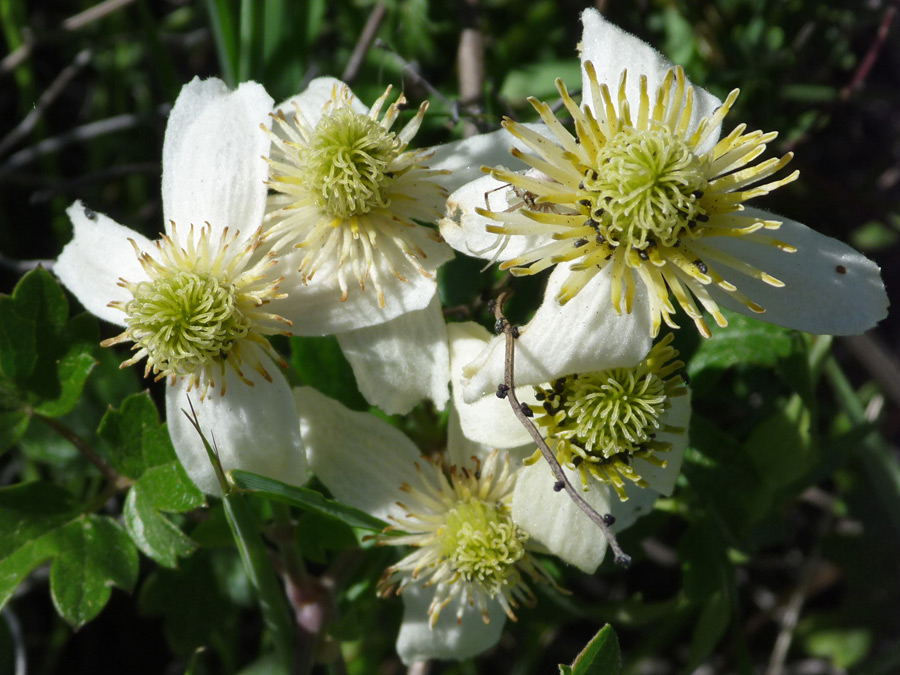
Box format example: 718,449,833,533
531,334,686,500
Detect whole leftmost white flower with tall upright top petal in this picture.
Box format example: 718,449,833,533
54,79,306,494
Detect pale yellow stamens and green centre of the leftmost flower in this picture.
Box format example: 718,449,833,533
101,223,291,399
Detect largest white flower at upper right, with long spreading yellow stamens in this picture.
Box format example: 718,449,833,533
441,9,888,360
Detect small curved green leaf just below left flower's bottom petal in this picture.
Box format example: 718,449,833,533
123,482,196,567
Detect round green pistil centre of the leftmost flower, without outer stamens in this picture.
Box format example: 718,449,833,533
125,272,252,376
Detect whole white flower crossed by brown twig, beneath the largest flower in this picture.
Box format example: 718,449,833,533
447,322,690,573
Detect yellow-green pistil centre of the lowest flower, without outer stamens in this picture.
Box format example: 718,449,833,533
439,498,527,594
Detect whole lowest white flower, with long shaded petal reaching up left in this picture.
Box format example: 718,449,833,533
294,387,560,664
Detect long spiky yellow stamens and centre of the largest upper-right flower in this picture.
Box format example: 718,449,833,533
476,61,798,336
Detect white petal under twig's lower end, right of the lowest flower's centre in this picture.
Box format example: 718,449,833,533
512,460,616,574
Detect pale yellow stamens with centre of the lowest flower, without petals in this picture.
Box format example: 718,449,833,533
378,452,555,627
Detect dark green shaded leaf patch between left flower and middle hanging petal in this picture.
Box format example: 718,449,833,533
291,336,369,410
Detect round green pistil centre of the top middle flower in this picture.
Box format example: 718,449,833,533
303,107,399,218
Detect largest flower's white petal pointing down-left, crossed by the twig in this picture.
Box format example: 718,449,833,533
463,265,651,402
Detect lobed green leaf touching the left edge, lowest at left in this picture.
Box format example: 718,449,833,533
0,483,138,628
